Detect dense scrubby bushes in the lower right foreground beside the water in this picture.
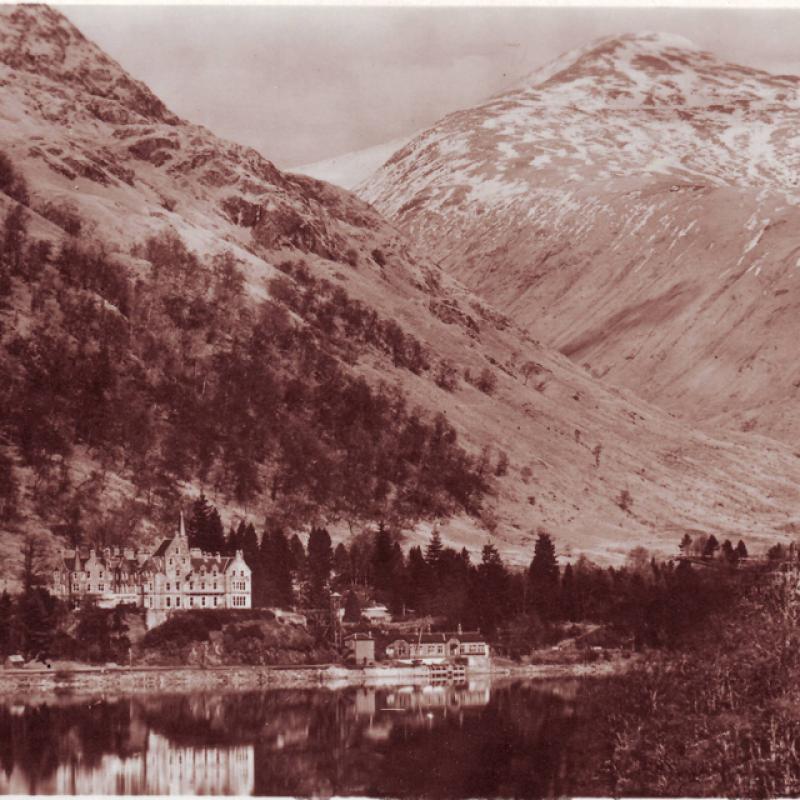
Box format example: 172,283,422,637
587,561,800,797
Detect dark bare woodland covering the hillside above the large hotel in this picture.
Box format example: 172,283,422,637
0,150,493,544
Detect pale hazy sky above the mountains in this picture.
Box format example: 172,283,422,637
58,5,800,168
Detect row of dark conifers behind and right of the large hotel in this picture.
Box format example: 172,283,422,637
189,488,748,655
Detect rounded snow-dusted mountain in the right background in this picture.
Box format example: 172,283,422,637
358,34,800,447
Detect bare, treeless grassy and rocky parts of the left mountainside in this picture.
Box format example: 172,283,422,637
0,7,800,580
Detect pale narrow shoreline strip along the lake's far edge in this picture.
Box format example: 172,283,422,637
0,661,630,697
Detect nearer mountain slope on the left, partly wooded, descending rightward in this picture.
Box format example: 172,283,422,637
0,6,800,575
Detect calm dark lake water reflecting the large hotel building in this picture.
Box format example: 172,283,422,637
0,682,605,798
